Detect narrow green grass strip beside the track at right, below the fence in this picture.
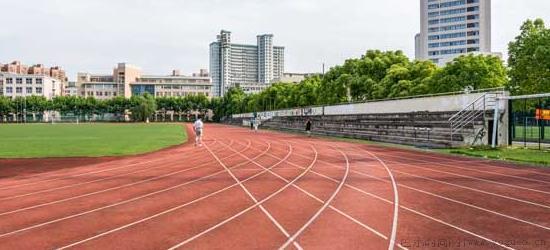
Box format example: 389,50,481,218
439,147,550,166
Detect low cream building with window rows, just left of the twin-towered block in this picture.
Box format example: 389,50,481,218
130,71,212,98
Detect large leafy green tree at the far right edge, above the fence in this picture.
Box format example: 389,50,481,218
508,19,550,94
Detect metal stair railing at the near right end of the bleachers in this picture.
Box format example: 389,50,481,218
449,92,503,141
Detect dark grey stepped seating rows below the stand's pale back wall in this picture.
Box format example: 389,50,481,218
262,112,490,148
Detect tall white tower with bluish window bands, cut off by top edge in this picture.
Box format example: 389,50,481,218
415,0,491,65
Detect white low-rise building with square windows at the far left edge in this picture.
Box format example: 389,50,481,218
0,73,62,100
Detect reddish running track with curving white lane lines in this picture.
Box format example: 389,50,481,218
0,125,550,249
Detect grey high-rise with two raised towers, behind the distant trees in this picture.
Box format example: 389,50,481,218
210,30,285,96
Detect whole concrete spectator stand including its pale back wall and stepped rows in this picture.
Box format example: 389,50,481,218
226,90,508,148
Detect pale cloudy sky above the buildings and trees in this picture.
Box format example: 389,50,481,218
0,0,550,80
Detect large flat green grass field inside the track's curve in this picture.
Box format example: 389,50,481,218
0,124,187,158
